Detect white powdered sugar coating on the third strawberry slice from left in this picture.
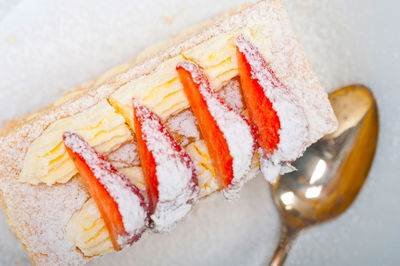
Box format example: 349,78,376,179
178,61,254,197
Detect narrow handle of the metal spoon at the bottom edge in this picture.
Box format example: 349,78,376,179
269,226,299,266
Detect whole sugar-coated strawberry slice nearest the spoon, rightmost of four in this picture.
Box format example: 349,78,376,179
235,35,309,182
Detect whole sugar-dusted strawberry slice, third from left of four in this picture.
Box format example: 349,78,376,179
177,61,254,192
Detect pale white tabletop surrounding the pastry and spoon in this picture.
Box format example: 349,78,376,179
0,0,400,265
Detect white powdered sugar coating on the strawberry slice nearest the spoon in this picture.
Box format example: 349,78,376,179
235,35,309,181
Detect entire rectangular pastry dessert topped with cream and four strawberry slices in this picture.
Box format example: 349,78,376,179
0,0,337,265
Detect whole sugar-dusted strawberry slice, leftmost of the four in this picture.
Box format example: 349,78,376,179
63,132,147,250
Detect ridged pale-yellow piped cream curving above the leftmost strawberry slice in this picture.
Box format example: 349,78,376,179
19,100,132,185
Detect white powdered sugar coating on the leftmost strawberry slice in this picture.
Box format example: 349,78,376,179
64,132,147,247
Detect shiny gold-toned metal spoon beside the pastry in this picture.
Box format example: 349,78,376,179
270,85,379,266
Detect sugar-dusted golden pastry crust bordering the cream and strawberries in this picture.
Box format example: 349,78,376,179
0,0,336,265
